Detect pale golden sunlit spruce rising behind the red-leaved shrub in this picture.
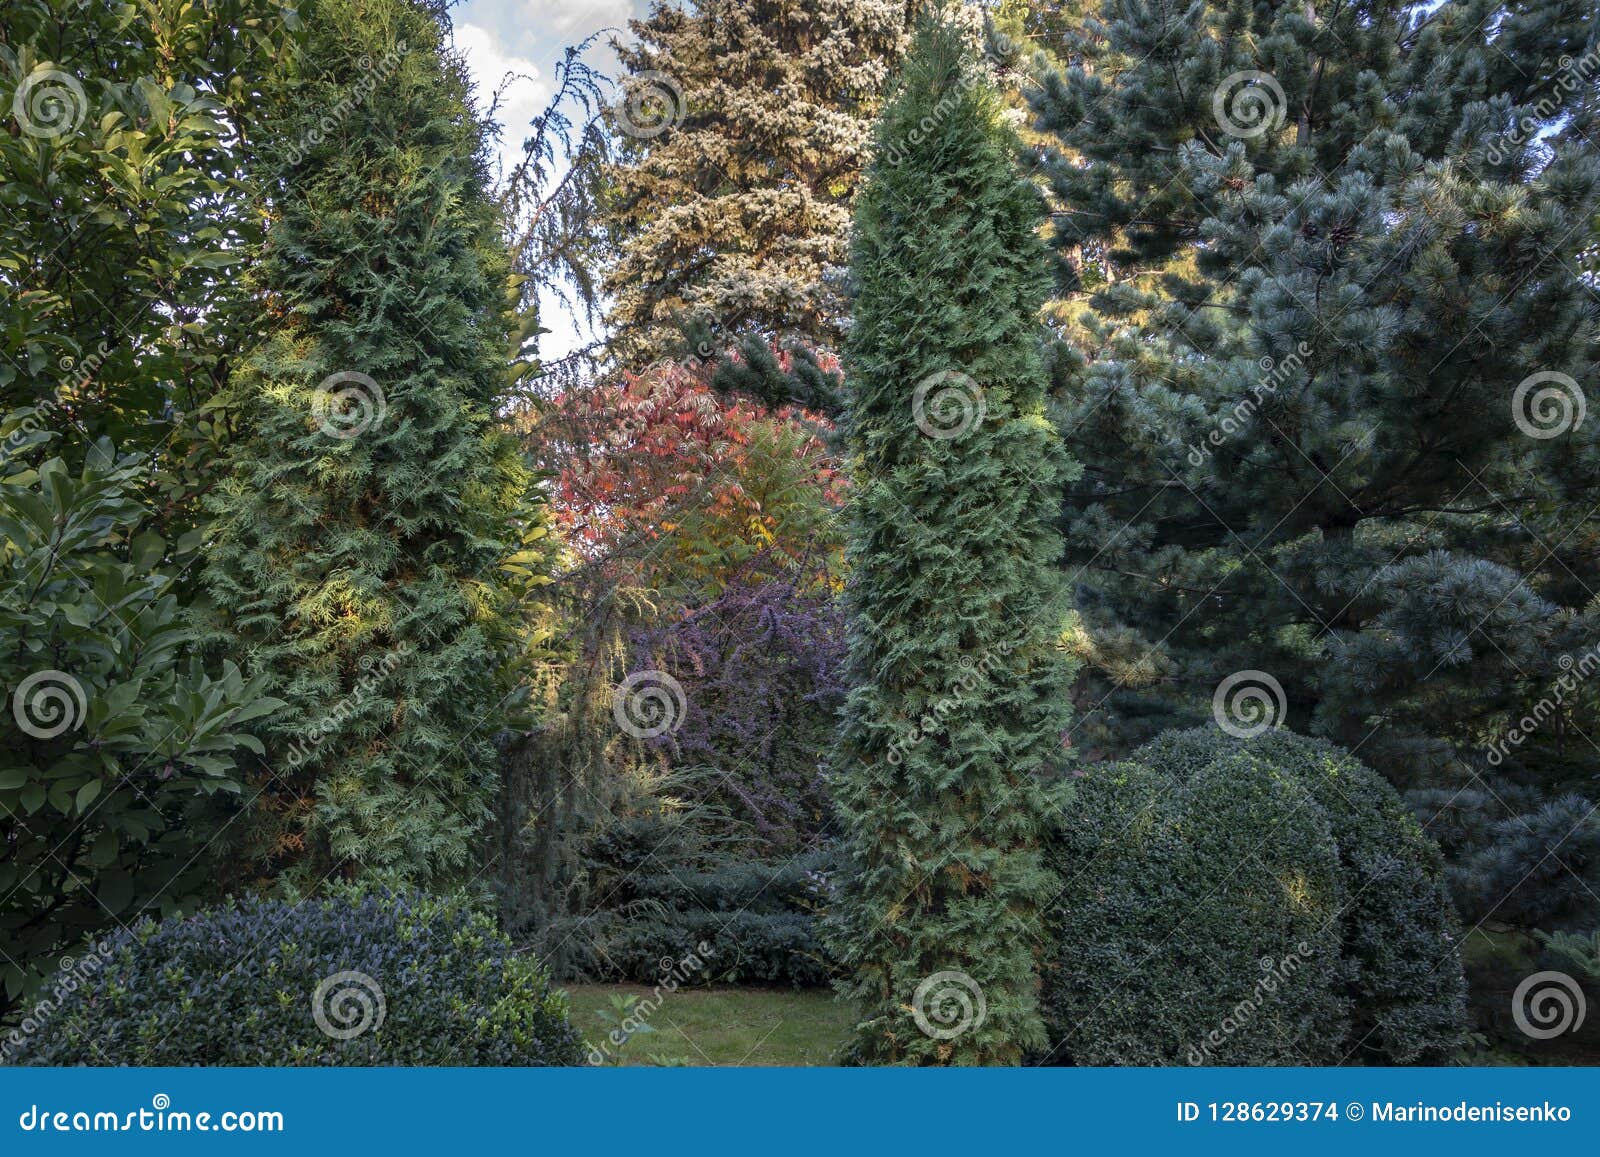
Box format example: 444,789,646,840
605,0,909,365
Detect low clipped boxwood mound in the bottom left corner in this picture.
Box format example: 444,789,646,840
7,895,582,1066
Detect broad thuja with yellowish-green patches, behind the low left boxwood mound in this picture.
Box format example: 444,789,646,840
210,0,528,882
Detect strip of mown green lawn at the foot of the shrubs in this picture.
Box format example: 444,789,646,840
566,984,854,1066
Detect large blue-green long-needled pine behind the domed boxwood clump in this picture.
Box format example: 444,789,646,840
1035,0,1600,934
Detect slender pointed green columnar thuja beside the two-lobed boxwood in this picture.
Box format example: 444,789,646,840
834,22,1067,1064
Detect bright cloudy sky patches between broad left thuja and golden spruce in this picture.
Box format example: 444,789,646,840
451,0,650,358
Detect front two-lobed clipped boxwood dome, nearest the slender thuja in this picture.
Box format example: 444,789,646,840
1043,752,1349,1064
